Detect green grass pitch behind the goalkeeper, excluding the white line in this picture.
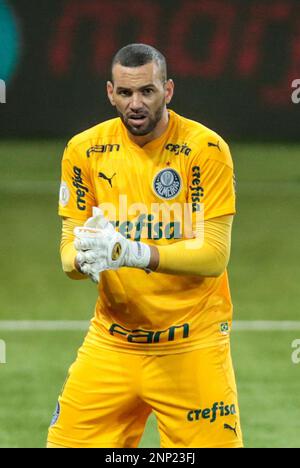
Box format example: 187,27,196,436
0,141,300,447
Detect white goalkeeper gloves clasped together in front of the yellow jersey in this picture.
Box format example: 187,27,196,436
74,208,151,283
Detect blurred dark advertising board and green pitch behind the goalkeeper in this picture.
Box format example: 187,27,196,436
0,0,300,447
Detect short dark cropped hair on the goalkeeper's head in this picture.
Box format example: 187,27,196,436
112,44,167,83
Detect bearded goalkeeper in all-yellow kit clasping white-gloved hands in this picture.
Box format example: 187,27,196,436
48,44,243,448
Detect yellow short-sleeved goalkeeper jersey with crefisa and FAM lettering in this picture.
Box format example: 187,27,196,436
59,110,235,354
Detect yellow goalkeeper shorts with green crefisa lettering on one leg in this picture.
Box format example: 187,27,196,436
48,332,243,448
